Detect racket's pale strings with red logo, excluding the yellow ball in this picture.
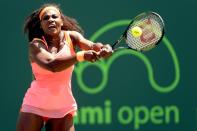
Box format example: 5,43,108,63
126,14,163,51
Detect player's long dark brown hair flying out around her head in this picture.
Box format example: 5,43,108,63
24,4,83,41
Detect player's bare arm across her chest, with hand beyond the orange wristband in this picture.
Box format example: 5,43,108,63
29,41,97,72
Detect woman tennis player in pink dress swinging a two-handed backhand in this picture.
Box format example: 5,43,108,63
17,4,113,131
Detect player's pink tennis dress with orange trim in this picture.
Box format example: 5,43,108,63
21,32,77,118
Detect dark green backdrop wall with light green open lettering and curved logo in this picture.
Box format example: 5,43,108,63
0,0,197,131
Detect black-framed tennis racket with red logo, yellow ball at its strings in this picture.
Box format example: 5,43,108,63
112,11,164,51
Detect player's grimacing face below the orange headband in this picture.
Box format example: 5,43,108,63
40,10,63,36
